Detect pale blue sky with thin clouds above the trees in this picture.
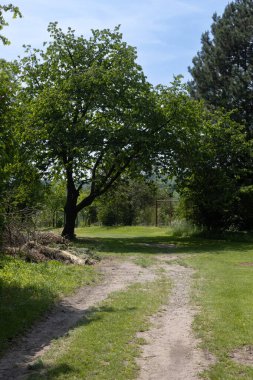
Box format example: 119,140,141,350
0,0,229,85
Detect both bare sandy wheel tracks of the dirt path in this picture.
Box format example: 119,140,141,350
0,255,211,380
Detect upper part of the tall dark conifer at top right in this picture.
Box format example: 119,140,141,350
189,0,253,137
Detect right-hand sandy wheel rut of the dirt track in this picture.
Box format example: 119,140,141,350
137,264,213,380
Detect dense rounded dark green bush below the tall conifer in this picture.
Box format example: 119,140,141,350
176,114,253,230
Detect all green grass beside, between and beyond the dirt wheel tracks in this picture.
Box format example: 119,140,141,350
0,227,253,380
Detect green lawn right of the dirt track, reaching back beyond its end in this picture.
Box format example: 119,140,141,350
72,227,253,380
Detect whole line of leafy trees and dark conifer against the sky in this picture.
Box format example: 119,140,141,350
0,0,253,239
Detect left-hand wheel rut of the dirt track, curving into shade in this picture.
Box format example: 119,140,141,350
0,259,155,380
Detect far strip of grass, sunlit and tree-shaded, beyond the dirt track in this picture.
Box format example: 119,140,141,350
66,226,253,257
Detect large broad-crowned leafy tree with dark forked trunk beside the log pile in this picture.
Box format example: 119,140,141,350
20,23,166,238
